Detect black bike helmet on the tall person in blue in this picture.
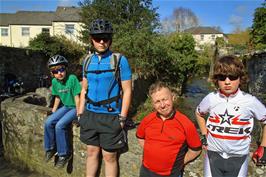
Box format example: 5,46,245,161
90,19,114,35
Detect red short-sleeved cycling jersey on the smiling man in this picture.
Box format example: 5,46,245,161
136,111,201,175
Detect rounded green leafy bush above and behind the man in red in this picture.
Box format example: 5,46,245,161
139,33,197,95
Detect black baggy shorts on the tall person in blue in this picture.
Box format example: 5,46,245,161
79,111,127,152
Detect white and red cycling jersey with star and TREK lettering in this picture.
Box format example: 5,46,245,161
197,89,266,158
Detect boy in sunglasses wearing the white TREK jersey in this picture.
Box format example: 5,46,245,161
196,56,266,177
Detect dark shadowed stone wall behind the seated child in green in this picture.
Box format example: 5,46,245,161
0,46,49,91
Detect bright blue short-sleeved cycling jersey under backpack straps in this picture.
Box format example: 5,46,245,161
83,51,131,114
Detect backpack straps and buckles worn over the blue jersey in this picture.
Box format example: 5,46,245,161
83,53,122,112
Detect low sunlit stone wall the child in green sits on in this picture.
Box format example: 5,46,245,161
1,93,266,177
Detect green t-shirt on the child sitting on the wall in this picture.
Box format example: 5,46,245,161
52,74,81,107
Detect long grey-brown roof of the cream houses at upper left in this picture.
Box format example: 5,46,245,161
0,7,80,26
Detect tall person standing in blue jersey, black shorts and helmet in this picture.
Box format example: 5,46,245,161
79,19,132,177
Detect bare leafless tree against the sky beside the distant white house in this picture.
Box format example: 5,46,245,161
162,7,199,32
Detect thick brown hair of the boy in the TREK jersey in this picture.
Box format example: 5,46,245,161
211,56,248,86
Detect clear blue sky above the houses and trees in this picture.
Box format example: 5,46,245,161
0,0,264,33
